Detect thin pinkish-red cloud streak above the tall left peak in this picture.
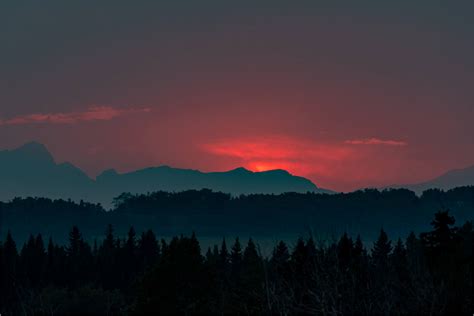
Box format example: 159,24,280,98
0,105,151,126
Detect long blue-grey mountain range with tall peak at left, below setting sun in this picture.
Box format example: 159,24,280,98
0,142,330,207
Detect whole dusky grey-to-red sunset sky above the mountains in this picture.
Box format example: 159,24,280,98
0,0,474,191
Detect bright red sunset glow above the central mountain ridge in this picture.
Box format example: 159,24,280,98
203,136,414,190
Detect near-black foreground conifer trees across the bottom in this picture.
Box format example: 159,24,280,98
0,211,474,315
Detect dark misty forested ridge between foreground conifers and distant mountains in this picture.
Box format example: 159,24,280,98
0,186,474,244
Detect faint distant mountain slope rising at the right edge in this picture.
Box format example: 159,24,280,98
390,166,474,194
